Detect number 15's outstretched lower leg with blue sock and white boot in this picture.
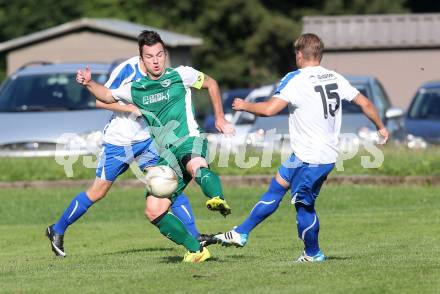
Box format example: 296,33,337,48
215,178,287,247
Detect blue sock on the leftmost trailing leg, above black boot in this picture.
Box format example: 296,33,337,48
54,192,93,235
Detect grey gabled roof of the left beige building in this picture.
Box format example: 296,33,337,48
0,18,203,52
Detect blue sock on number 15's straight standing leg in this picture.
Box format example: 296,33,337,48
295,203,319,256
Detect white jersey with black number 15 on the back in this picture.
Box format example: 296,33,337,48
274,66,359,164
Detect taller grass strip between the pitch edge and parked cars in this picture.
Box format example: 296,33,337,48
0,146,440,181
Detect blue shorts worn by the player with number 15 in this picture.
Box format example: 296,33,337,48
278,154,335,206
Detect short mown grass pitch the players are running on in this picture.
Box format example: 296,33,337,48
0,186,440,294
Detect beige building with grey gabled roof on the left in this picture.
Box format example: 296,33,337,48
0,18,203,74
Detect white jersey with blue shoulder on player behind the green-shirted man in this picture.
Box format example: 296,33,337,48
103,56,150,146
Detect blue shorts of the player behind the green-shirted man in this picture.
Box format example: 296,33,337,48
96,138,159,182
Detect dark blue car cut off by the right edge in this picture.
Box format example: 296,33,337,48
405,81,440,147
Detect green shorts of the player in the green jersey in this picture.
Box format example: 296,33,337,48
151,137,208,202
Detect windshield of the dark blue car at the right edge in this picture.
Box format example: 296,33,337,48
408,88,440,120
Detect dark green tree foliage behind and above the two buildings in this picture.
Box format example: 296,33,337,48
0,0,439,88
